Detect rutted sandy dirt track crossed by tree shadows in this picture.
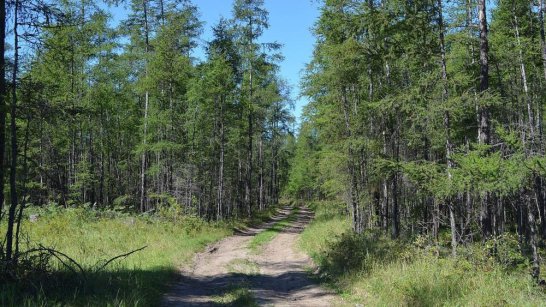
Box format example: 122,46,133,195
160,207,334,307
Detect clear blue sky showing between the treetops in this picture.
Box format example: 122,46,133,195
112,0,319,124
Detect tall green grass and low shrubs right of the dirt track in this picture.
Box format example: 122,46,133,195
300,203,546,306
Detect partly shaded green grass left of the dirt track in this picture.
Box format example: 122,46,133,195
0,207,278,306
